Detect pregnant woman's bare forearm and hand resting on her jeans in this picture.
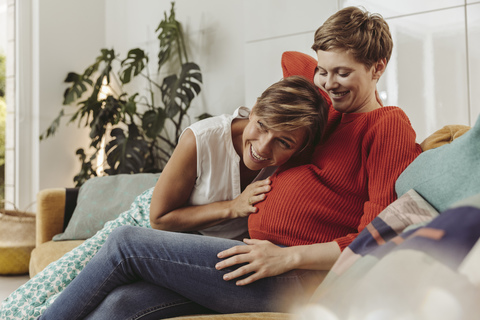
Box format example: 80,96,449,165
215,239,341,286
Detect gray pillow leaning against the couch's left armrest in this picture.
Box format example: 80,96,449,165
53,173,160,241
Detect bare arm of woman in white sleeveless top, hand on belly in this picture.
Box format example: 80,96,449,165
150,130,270,231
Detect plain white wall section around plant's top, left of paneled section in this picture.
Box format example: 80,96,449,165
106,0,245,119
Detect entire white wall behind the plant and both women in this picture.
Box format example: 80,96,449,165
13,0,480,209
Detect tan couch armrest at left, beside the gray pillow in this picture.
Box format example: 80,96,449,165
35,188,66,246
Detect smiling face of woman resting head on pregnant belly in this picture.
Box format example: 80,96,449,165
243,112,307,170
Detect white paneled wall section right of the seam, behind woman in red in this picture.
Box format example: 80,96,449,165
245,0,480,142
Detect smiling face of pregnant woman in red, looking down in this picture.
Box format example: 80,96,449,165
315,49,385,113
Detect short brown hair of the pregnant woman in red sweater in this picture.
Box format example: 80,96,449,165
312,7,393,69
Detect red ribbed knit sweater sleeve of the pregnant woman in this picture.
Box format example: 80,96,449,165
334,108,422,251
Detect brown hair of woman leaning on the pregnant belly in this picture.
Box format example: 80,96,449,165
252,76,328,147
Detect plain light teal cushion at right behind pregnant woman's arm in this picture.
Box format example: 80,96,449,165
395,116,480,212
